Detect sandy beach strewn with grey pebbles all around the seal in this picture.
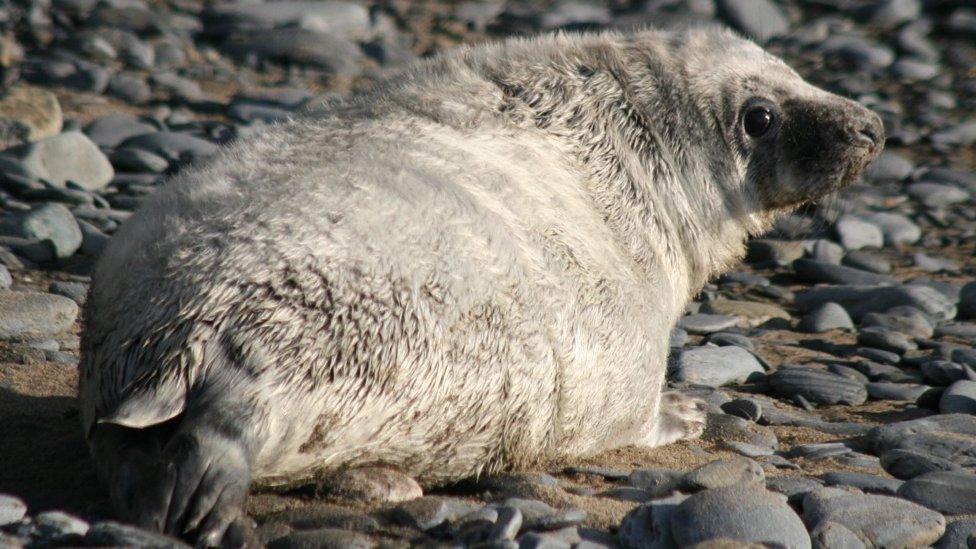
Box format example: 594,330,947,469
0,0,976,548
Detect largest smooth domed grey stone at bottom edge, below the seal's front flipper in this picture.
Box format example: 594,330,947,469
670,485,810,548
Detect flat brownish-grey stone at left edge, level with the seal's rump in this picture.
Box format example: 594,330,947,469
0,290,78,339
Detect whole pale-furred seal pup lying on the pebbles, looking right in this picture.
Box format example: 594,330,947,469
79,29,884,545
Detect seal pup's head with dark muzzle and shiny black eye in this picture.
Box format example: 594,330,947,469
679,31,885,210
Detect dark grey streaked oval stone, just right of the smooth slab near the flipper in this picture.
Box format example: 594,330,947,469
768,364,868,406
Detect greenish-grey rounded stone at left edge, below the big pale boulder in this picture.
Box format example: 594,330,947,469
0,203,82,259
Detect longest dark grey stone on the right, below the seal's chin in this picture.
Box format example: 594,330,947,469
795,285,956,320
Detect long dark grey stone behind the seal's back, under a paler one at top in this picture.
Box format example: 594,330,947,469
221,28,365,77
